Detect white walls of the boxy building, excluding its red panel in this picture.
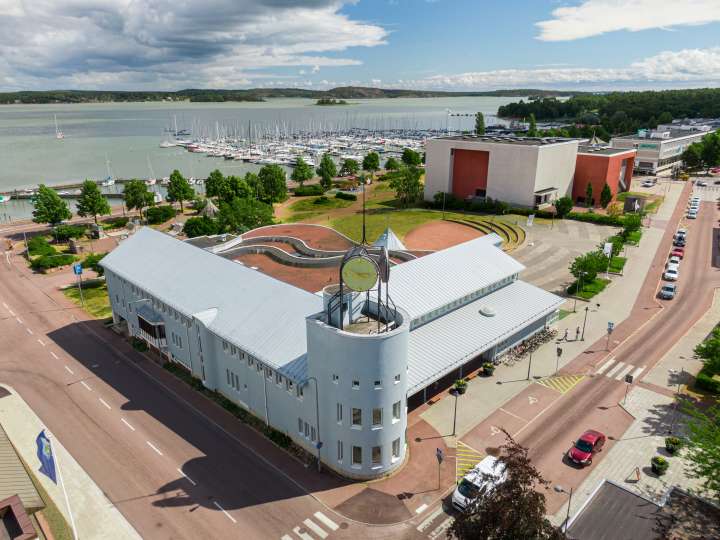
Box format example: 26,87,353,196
424,137,578,207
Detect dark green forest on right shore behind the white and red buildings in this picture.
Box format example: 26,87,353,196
498,88,720,134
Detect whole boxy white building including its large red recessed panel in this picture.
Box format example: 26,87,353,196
424,135,578,207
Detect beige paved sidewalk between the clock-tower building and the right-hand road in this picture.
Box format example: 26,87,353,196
420,179,686,450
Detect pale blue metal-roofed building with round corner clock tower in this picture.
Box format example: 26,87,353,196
101,228,563,479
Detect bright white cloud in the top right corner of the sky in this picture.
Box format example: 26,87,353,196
536,0,720,41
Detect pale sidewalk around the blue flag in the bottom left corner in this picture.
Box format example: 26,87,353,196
0,385,140,540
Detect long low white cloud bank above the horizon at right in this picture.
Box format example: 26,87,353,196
387,47,720,90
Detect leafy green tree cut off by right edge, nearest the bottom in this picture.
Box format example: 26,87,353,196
684,403,720,499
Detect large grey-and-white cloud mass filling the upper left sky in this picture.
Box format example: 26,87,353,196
0,0,387,89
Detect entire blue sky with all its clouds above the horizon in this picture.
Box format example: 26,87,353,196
0,0,720,90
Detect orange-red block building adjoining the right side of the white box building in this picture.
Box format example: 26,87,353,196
572,145,635,205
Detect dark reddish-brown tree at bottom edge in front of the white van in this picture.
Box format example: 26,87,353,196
448,429,563,540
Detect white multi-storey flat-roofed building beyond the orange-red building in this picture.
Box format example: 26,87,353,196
610,128,712,174
